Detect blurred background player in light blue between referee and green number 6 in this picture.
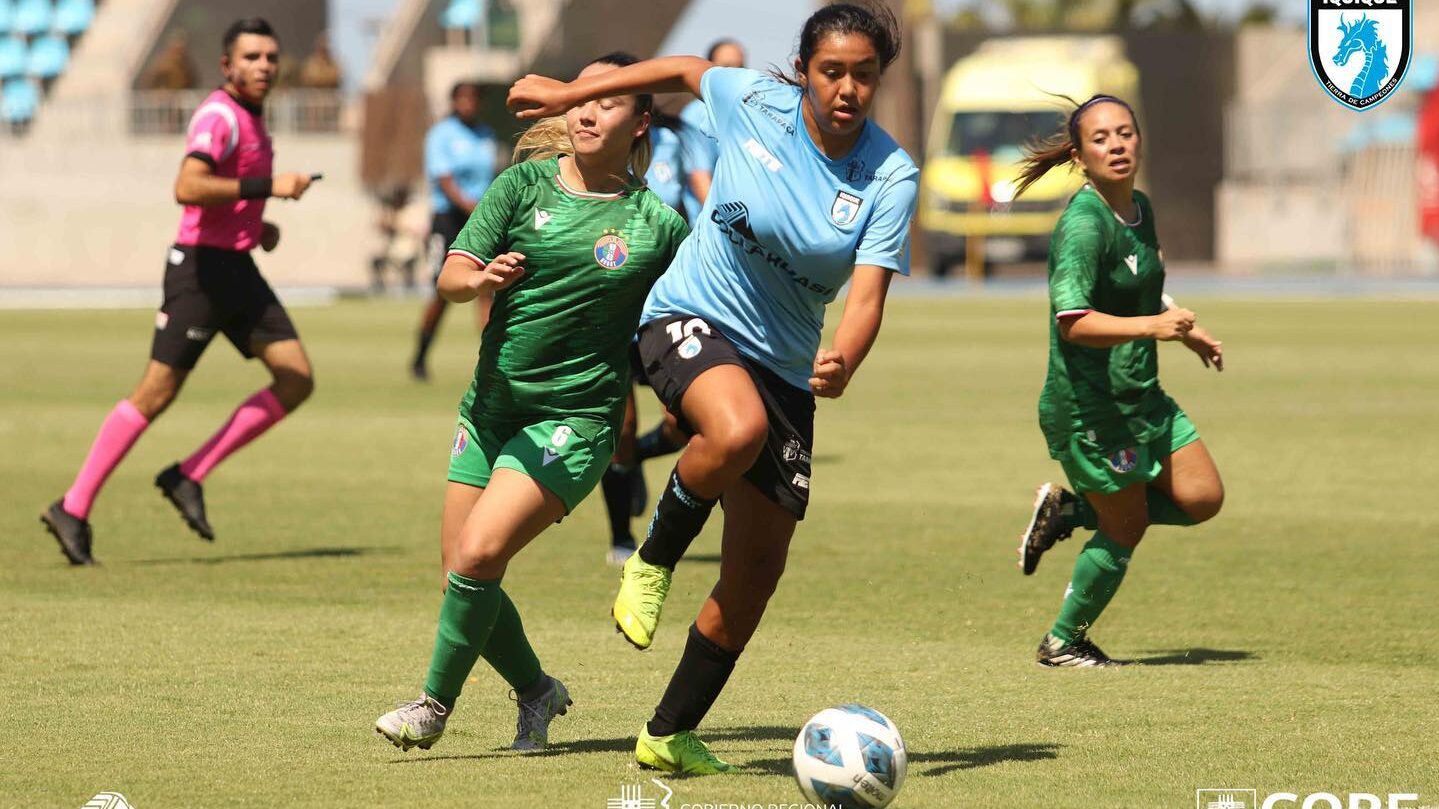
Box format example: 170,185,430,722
410,82,495,380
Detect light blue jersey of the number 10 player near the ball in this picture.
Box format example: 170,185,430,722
640,68,920,390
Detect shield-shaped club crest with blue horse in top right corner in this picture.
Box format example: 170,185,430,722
1309,0,1415,112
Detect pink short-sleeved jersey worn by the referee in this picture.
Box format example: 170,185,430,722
176,89,275,250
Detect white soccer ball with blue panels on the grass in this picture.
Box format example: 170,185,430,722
794,705,909,809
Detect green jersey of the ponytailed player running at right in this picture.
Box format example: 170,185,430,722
1039,186,1171,458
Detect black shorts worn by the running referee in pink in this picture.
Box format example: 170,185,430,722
150,245,299,370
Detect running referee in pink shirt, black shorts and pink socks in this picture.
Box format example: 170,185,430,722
40,19,315,564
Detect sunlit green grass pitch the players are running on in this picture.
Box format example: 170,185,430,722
0,298,1439,809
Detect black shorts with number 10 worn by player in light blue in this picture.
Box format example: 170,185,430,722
639,315,814,520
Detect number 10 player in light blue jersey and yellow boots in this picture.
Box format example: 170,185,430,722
509,3,918,774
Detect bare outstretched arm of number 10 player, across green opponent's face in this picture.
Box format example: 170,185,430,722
505,56,714,121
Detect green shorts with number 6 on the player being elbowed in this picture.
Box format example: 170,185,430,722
449,417,614,514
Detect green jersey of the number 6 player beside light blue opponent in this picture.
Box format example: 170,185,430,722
449,158,689,429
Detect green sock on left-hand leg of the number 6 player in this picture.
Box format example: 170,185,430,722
425,573,504,708
